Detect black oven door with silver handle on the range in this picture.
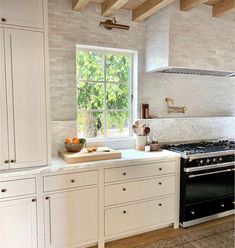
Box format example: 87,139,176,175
185,168,233,204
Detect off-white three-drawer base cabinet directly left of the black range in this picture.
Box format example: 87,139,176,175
104,160,179,241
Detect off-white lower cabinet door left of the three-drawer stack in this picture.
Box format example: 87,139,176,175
44,188,99,248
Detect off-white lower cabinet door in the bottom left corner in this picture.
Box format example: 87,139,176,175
0,198,37,248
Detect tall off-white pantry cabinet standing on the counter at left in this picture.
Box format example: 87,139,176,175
0,0,49,170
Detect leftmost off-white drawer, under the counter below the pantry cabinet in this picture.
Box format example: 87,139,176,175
0,178,36,199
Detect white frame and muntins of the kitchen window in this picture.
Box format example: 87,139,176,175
76,45,138,141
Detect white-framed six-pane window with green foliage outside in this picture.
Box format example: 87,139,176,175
76,46,133,138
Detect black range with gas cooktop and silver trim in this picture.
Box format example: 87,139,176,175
162,140,235,227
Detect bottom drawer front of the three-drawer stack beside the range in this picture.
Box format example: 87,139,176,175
105,196,175,237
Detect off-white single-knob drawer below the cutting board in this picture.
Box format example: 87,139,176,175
44,171,99,192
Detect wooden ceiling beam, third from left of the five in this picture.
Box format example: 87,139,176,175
132,0,174,22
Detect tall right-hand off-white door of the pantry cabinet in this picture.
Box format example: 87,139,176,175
0,28,47,168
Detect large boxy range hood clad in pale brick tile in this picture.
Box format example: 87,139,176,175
146,1,235,77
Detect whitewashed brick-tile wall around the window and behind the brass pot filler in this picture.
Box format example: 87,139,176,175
48,0,235,154
